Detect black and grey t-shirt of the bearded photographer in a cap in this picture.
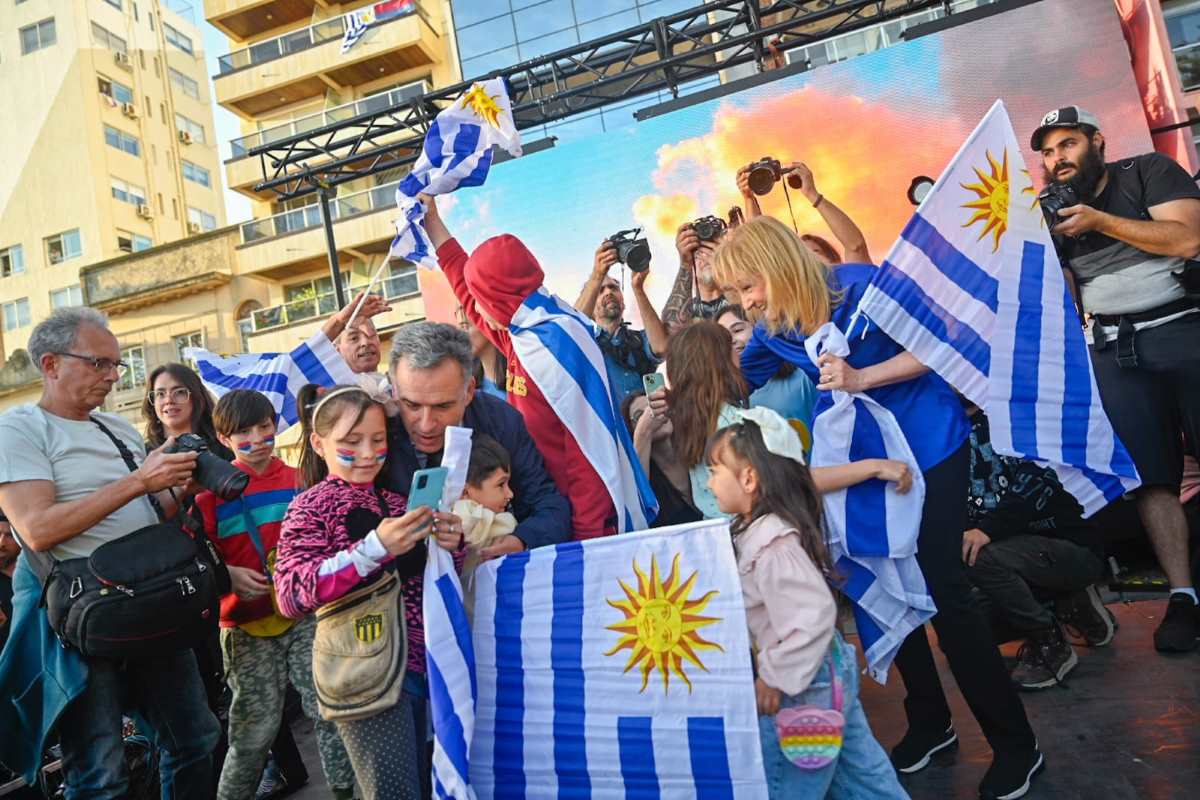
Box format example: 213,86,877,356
1055,152,1200,314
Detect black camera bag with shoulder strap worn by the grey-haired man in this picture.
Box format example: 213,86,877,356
25,417,228,658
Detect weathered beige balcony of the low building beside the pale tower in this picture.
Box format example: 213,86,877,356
79,227,238,314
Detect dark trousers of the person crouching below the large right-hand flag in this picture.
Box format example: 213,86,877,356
967,534,1104,636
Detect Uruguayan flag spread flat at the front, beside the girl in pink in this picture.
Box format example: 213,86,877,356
470,521,767,800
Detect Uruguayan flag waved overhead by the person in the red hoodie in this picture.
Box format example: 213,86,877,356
390,78,521,269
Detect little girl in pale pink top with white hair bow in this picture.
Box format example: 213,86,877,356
707,409,908,800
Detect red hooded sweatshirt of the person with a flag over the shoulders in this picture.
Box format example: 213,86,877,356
438,234,617,539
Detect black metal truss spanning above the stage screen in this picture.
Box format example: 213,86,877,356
248,0,949,199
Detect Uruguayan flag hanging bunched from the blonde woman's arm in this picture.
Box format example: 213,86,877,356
804,323,936,684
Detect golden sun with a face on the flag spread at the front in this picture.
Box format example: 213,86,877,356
605,554,724,694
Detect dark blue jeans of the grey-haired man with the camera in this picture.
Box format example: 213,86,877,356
58,650,221,800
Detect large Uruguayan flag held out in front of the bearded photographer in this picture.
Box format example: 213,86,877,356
859,101,1140,515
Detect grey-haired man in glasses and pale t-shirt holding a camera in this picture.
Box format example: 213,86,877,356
0,307,220,799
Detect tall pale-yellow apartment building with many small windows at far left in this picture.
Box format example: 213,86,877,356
0,0,226,372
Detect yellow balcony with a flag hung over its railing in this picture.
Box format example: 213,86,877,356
214,4,445,120
